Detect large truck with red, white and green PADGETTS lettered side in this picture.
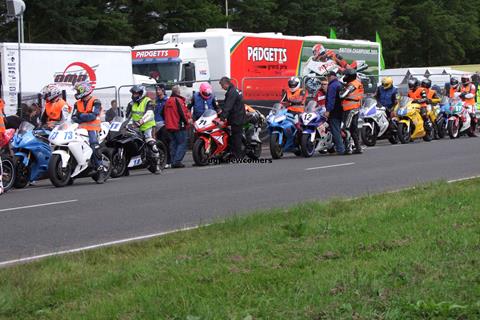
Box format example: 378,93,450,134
132,29,380,105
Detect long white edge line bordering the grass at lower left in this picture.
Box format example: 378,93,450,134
0,224,201,267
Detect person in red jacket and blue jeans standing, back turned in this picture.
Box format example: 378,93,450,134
162,85,192,168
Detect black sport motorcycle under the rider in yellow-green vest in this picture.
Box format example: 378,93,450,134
106,117,167,178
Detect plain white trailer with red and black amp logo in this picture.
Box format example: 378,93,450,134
0,43,134,115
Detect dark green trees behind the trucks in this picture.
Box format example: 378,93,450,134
0,0,480,68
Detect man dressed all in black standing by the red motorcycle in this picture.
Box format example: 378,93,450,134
220,77,246,159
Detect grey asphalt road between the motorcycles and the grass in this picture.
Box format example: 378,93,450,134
0,138,480,266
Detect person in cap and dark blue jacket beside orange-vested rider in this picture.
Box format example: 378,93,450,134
325,71,345,155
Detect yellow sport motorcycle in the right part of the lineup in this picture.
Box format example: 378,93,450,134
395,96,434,143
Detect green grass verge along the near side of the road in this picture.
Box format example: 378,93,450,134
0,180,480,320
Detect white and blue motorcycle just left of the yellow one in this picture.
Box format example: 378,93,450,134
360,97,398,147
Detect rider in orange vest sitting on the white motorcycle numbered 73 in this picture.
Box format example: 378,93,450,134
72,81,107,182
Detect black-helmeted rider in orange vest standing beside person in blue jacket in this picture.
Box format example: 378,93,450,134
340,68,365,154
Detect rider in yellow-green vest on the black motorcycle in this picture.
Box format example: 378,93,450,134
126,85,161,173
